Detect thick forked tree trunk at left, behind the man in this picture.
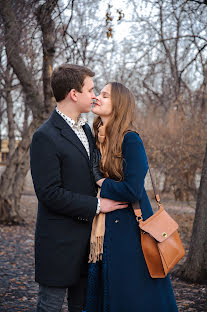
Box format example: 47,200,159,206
0,0,58,224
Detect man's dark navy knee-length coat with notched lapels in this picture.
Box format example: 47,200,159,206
30,111,97,287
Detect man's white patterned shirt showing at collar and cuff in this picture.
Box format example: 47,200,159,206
55,107,101,214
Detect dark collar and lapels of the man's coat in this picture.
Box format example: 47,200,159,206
49,110,93,162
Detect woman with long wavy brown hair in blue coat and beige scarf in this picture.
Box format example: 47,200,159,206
86,82,177,312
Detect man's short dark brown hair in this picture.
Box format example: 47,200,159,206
51,64,95,102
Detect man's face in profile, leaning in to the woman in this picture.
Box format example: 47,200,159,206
76,76,95,113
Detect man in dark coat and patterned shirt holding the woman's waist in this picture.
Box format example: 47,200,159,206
31,64,127,312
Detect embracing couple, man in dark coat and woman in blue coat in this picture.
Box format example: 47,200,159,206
31,64,177,312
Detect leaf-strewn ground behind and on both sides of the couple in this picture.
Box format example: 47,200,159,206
0,194,207,312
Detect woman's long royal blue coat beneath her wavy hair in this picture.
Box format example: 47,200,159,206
86,132,177,312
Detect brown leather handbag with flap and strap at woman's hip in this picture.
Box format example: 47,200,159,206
133,169,185,278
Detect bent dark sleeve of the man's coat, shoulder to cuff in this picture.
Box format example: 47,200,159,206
30,131,97,221
